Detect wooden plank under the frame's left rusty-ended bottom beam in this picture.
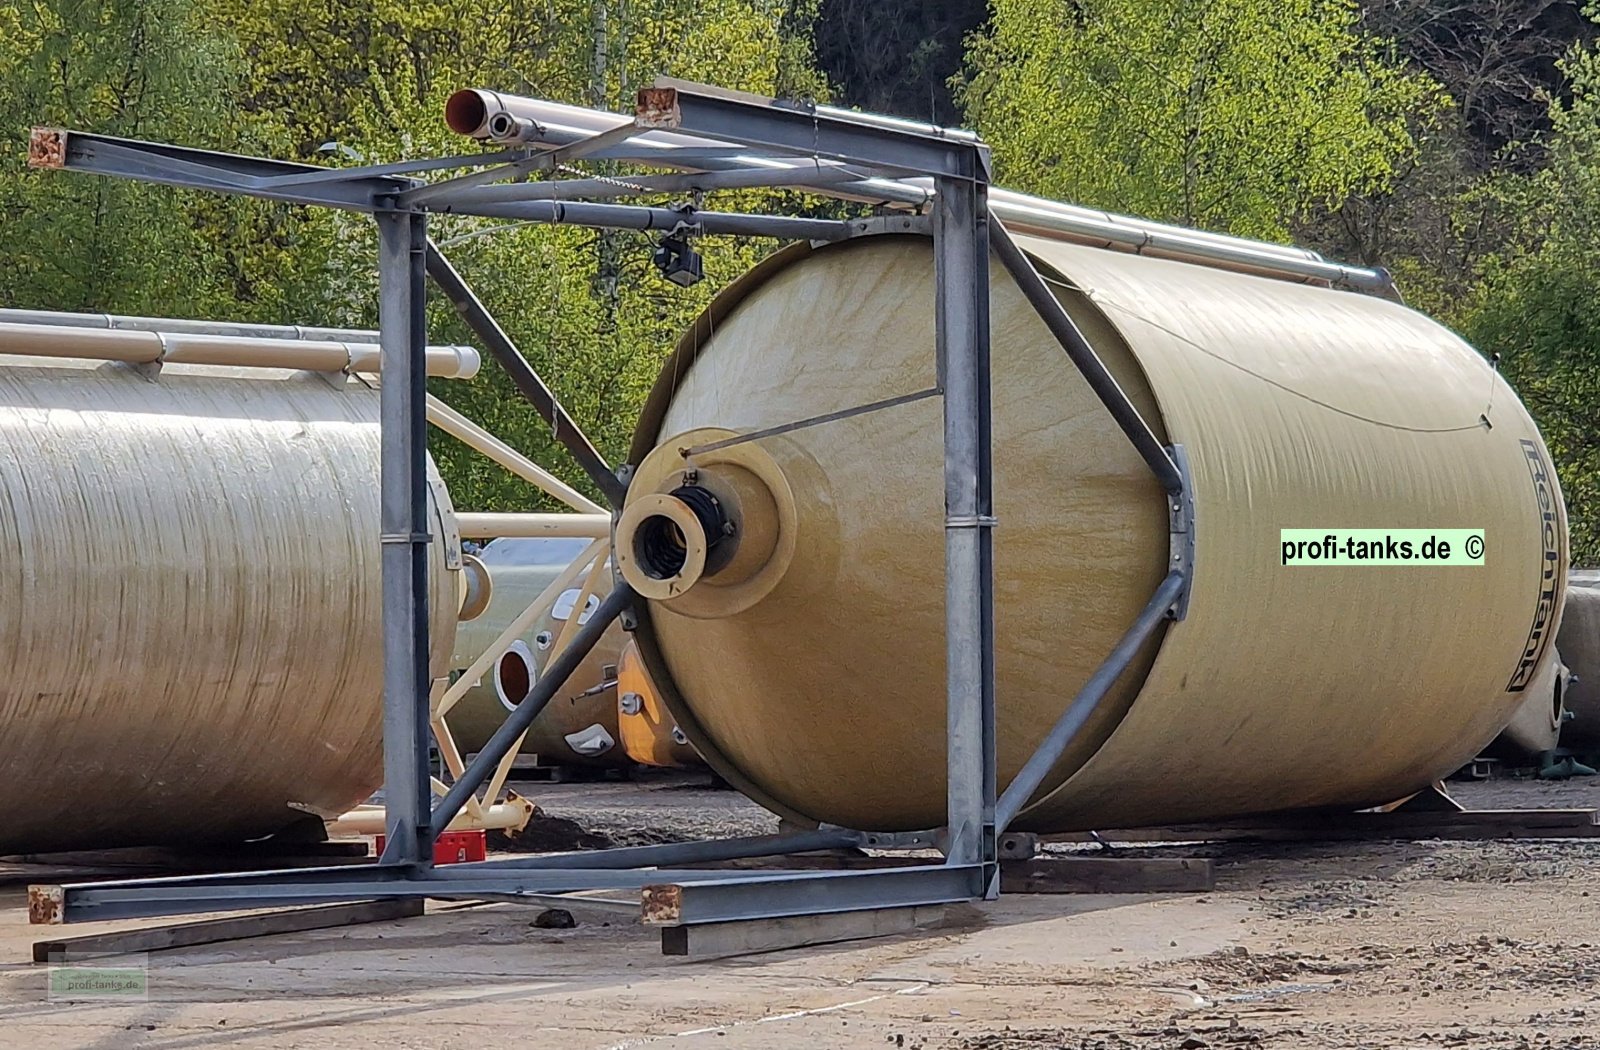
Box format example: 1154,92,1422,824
34,898,424,962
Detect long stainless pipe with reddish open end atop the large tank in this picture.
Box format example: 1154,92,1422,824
445,88,1394,295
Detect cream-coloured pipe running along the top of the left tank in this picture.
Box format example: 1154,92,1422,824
0,322,482,379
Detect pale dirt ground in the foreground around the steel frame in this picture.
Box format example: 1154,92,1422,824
0,778,1600,1050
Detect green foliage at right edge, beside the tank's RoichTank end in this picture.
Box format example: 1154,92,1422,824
1462,50,1600,565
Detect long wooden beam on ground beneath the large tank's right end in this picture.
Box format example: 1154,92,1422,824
1042,810,1600,842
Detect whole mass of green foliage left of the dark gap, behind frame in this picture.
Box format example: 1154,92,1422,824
0,0,826,509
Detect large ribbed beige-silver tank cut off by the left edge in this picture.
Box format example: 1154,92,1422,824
0,357,459,853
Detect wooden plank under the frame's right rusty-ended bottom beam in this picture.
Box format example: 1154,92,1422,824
661,904,946,959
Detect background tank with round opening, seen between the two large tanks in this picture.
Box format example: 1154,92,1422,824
450,538,630,767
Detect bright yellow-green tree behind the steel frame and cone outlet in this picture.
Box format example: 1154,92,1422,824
195,0,822,509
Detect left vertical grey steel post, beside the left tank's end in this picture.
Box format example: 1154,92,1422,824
376,211,434,864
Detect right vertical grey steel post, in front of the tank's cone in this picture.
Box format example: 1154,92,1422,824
933,172,998,896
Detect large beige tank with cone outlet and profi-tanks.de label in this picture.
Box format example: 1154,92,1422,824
616,237,1566,831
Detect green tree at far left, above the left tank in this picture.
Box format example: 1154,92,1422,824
0,0,234,312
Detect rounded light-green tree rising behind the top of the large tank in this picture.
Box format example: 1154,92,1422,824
960,0,1442,240
